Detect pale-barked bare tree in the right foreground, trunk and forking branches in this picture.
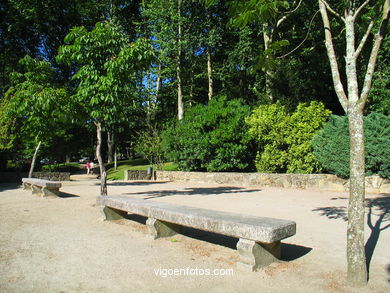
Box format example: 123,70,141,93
318,0,390,284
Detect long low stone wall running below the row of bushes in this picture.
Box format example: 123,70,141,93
156,171,390,193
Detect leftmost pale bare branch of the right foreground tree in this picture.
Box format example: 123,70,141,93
318,0,348,113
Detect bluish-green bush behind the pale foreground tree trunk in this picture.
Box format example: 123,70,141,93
312,112,390,178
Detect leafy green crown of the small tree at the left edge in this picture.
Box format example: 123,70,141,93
0,56,68,149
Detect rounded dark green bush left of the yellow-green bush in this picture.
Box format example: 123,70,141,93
163,97,253,171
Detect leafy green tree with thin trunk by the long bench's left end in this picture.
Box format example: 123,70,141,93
57,21,153,195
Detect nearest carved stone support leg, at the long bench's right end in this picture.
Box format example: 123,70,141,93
237,238,281,272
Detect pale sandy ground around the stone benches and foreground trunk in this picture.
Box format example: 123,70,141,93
0,180,390,293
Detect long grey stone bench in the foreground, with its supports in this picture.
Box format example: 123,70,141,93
97,196,296,271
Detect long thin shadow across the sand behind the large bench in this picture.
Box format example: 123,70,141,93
126,186,261,199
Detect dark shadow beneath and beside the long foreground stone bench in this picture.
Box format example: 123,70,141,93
126,214,312,261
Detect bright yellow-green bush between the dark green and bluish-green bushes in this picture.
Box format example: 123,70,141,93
246,102,330,173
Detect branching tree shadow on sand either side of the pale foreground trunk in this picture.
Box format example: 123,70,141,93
312,193,390,274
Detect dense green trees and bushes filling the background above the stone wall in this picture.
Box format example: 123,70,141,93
0,0,390,177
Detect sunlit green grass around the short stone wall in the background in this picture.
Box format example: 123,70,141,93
106,159,177,180
